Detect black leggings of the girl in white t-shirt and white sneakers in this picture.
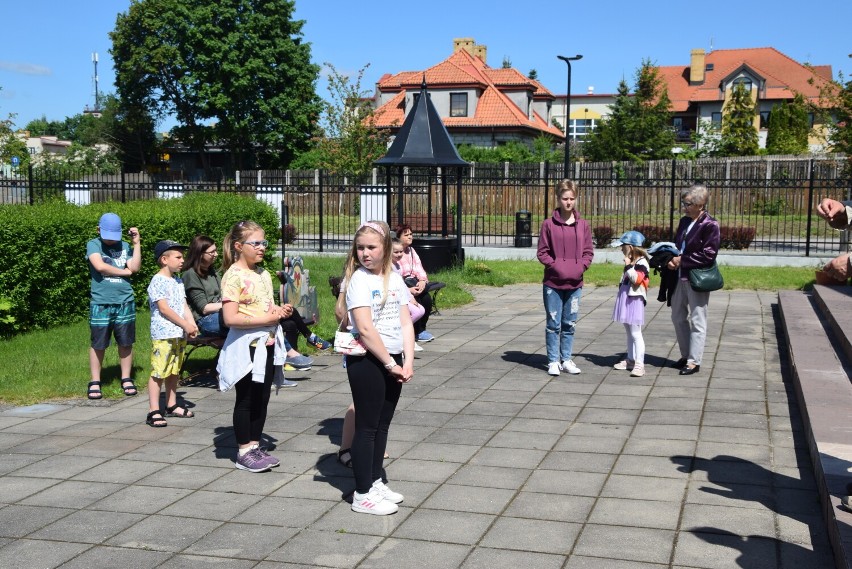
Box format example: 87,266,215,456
346,353,402,494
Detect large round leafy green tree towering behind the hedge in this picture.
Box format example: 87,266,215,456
110,0,320,168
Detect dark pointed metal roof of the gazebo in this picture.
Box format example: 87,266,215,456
375,78,469,167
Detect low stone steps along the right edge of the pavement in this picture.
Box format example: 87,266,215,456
778,287,852,569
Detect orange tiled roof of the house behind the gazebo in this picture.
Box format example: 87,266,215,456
375,50,565,138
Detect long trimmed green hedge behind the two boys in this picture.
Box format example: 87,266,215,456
0,193,280,337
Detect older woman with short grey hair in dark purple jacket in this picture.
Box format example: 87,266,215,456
667,184,720,375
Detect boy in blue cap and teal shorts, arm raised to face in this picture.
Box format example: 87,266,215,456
86,213,142,399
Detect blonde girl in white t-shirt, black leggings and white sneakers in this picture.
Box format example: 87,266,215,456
344,221,414,516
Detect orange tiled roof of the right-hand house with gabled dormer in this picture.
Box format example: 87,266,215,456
659,47,831,112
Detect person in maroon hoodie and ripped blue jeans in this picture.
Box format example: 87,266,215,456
537,180,595,375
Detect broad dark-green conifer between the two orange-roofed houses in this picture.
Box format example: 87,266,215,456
582,59,675,162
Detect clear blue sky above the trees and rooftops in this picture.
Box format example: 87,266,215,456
0,0,852,130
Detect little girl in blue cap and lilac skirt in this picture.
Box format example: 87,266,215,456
612,231,650,377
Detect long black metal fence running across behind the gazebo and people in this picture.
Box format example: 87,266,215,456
0,156,852,255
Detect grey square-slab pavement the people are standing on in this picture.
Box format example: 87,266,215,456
0,285,834,569
